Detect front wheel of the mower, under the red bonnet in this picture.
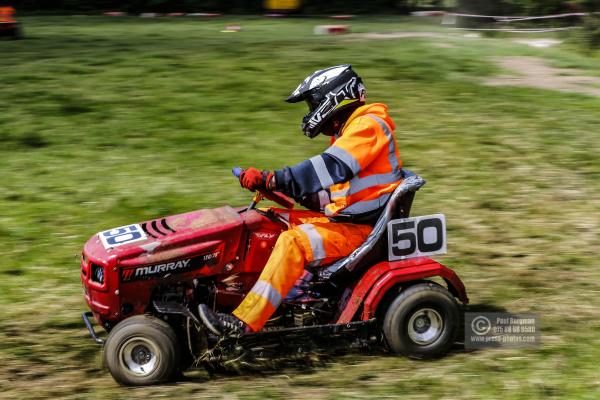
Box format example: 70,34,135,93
104,315,179,386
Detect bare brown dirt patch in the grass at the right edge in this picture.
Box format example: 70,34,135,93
484,57,600,97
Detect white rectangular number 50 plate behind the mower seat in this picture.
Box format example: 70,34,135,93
388,214,446,261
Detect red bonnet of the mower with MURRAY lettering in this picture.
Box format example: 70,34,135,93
81,207,286,326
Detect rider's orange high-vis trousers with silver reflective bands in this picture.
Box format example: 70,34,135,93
233,210,372,332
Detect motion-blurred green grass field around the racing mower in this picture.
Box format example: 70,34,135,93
0,16,600,399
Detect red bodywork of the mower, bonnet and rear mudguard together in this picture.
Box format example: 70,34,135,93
81,206,467,330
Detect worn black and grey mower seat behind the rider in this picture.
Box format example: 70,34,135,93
316,170,425,284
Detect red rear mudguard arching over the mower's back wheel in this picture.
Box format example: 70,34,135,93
337,257,469,324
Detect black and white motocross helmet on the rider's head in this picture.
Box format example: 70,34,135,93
286,64,366,138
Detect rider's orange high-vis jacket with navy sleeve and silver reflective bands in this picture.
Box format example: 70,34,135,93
275,103,402,217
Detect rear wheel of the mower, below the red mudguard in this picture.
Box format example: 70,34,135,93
383,282,459,358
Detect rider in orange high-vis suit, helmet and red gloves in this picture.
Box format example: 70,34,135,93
199,65,402,335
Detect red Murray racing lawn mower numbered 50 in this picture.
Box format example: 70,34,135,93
81,169,468,385
